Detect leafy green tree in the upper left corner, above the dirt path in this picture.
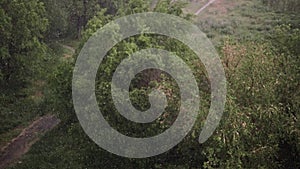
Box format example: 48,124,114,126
0,0,48,91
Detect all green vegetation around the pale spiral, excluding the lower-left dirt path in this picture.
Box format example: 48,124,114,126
0,0,300,169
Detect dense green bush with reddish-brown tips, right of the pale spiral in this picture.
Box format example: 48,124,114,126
203,35,300,168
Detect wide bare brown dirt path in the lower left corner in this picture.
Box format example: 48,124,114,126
0,115,60,169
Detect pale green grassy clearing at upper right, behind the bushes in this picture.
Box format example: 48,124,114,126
187,0,300,46
